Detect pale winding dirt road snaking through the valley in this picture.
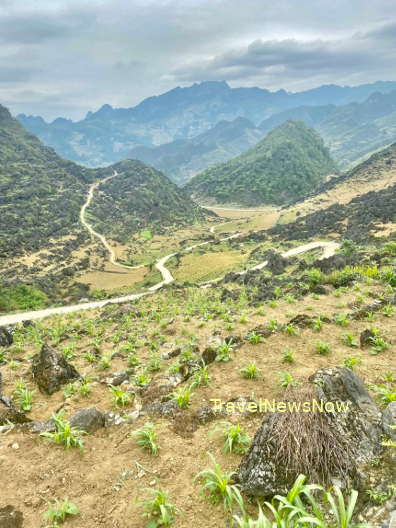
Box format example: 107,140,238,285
0,177,340,326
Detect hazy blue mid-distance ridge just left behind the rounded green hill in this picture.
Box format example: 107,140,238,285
131,117,263,185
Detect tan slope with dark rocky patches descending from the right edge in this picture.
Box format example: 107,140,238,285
272,143,396,242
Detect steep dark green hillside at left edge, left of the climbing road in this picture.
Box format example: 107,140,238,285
0,106,93,258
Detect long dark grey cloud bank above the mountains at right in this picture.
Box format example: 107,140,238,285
173,25,396,86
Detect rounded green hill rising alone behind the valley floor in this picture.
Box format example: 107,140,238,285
186,121,336,205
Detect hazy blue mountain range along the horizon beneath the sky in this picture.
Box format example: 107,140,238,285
18,81,396,172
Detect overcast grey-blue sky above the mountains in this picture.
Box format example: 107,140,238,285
0,0,396,119
